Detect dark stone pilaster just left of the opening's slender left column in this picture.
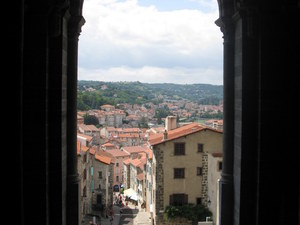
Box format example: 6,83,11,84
48,3,69,225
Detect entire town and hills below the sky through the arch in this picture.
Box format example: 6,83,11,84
77,80,223,225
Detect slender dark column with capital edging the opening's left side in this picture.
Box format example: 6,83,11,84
67,1,85,225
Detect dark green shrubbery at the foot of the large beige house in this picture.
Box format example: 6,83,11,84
165,204,212,222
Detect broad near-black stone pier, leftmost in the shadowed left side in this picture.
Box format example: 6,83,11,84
21,3,49,225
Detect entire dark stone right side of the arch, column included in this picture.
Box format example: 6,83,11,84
216,0,300,225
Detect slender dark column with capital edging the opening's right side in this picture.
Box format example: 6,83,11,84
216,1,234,225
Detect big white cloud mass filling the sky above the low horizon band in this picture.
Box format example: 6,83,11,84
79,0,223,84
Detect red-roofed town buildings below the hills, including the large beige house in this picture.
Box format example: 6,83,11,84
77,100,223,224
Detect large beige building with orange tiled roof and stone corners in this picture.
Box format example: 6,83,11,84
149,123,222,225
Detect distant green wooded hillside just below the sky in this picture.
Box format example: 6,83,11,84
78,80,223,110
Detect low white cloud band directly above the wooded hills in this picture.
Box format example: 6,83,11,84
78,66,223,85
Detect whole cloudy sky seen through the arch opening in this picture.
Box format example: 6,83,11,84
78,0,223,85
